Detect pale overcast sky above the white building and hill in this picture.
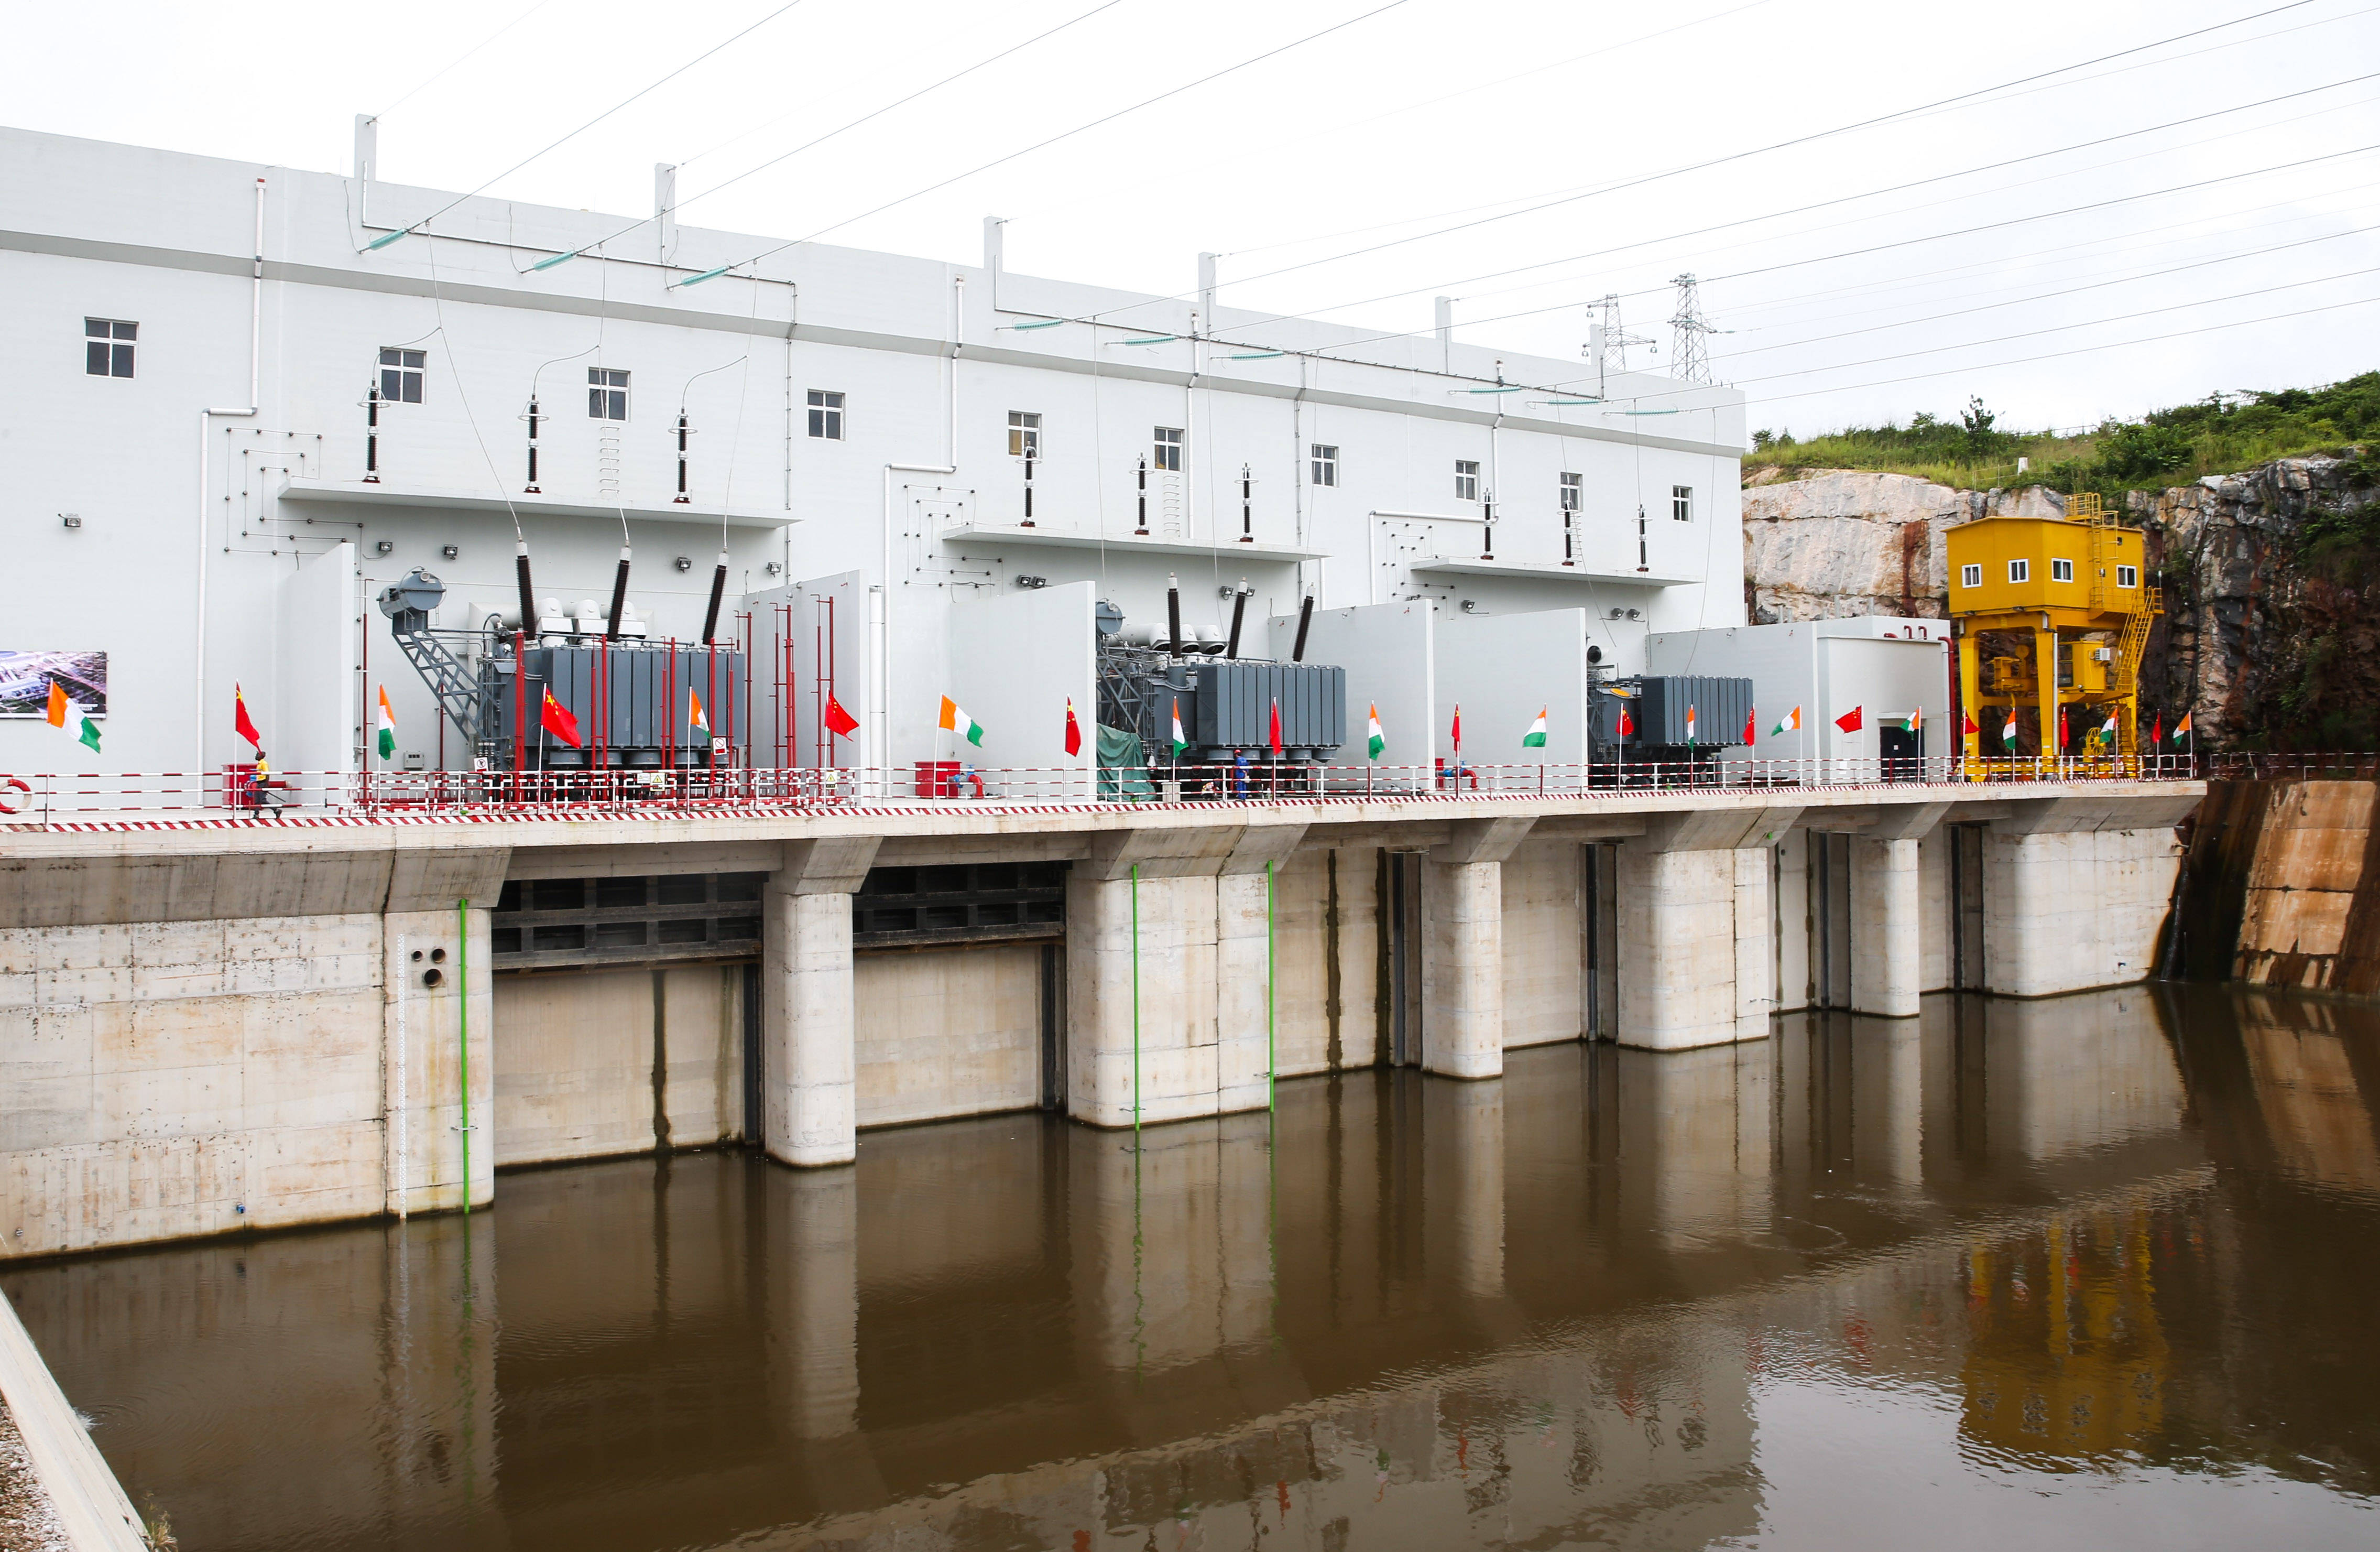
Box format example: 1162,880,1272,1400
0,0,2380,436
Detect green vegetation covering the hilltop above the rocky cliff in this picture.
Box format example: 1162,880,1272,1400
1744,371,2380,505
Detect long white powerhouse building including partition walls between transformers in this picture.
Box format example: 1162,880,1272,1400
0,131,1742,790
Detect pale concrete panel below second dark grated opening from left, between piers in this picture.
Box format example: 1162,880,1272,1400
852,942,1042,1126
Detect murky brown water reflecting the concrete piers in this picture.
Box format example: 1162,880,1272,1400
0,990,2380,1552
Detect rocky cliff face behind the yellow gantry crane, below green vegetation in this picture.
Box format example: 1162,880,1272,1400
1744,457,2380,750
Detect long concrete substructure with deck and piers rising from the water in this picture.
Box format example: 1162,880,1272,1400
0,783,2199,1276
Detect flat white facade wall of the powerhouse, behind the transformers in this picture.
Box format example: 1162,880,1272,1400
0,120,1742,771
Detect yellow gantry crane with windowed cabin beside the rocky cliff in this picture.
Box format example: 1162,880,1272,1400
1947,493,2164,778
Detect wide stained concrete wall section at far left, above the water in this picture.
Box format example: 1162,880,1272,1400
0,916,385,1257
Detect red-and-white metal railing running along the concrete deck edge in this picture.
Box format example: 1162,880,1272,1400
0,755,2208,826
